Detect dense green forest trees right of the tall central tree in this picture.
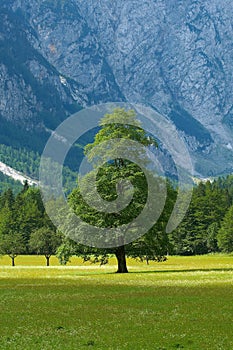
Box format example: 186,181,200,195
169,175,233,255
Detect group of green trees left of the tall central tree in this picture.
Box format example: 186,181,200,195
0,183,62,266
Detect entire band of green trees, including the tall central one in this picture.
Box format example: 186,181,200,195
0,109,233,273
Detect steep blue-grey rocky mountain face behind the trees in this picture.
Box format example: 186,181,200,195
0,0,233,176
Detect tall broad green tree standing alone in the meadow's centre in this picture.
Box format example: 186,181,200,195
63,108,167,273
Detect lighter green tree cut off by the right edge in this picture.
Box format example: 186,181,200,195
217,206,233,253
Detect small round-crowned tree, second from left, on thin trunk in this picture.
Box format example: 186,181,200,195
29,227,62,266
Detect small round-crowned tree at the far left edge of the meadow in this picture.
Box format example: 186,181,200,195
0,233,26,266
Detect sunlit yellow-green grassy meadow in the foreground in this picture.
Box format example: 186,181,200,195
0,255,233,350
